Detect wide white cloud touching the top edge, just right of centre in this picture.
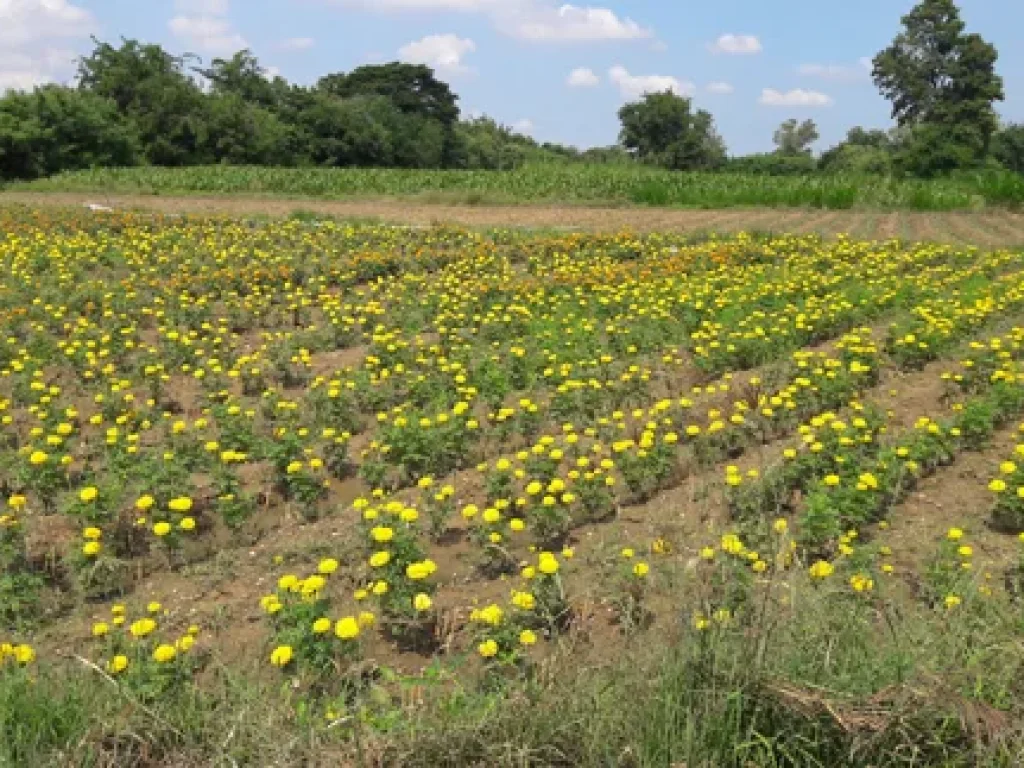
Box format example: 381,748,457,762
500,2,653,42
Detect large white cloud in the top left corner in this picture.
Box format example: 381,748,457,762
0,0,96,93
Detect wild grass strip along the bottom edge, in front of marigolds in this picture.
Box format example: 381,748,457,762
0,581,1024,768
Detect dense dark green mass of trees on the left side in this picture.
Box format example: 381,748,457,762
0,40,598,178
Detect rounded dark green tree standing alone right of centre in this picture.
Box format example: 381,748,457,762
618,91,725,170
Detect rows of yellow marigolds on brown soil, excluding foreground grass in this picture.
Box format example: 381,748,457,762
0,210,1024,759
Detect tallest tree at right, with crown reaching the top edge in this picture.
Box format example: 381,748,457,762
871,0,1004,174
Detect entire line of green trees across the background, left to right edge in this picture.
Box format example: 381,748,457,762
0,0,1024,178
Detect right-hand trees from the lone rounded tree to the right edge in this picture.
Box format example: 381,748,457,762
618,0,1024,177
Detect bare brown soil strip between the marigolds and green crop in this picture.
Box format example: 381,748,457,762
6,193,1024,246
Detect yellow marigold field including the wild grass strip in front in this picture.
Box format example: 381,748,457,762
6,208,1024,766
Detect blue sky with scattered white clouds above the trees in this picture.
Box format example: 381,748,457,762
0,0,1024,154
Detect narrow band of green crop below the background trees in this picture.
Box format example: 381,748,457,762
7,165,1024,211
